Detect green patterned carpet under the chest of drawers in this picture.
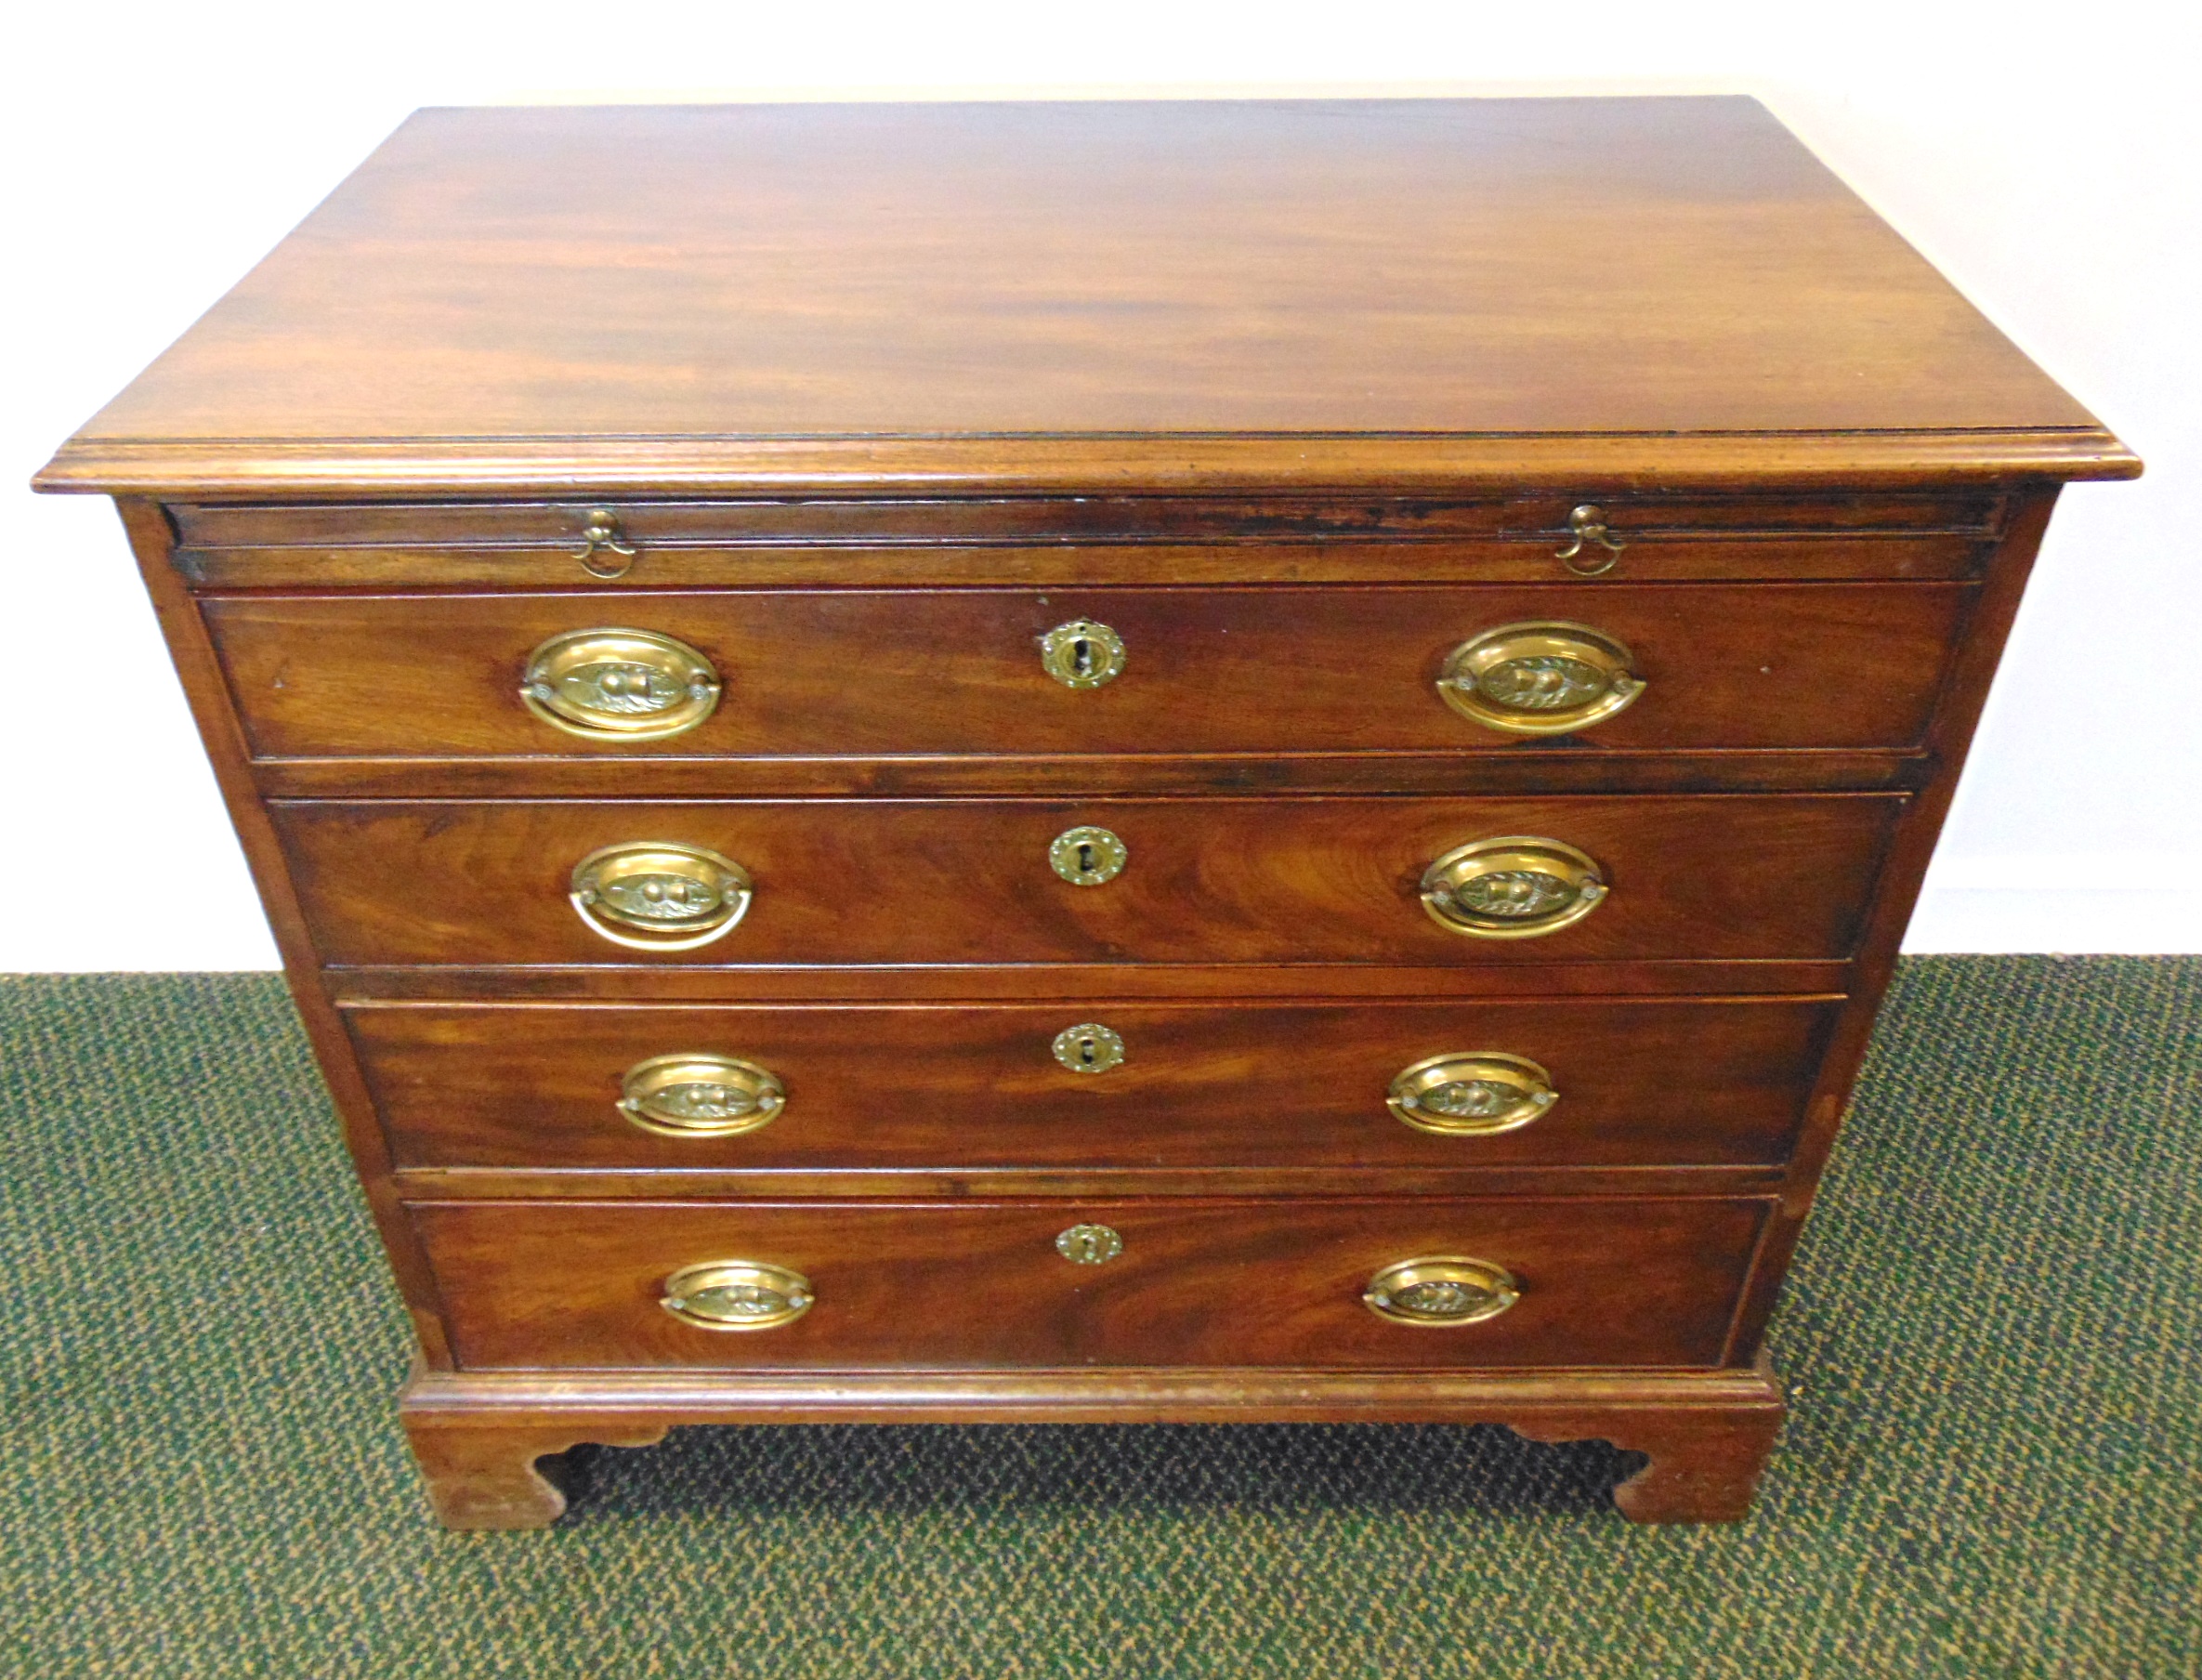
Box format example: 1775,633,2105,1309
0,958,2202,1680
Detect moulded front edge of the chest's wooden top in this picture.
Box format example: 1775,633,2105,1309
31,425,2141,502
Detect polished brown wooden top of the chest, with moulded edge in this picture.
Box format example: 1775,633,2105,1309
42,99,2134,495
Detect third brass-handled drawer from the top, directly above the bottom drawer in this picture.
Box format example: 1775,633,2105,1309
346,997,1841,1169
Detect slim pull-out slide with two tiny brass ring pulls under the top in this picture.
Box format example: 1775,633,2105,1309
169,489,2004,588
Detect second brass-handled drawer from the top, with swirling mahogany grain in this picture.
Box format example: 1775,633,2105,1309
269,793,1905,966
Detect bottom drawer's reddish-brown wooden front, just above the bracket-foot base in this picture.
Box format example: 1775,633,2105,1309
410,1198,1768,1370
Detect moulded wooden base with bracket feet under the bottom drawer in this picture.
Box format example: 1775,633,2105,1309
399,1360,1786,1528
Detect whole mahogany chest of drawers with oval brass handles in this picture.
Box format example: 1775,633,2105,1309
40,99,2138,1526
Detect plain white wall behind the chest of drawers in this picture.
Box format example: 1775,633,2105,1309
0,0,2202,971
